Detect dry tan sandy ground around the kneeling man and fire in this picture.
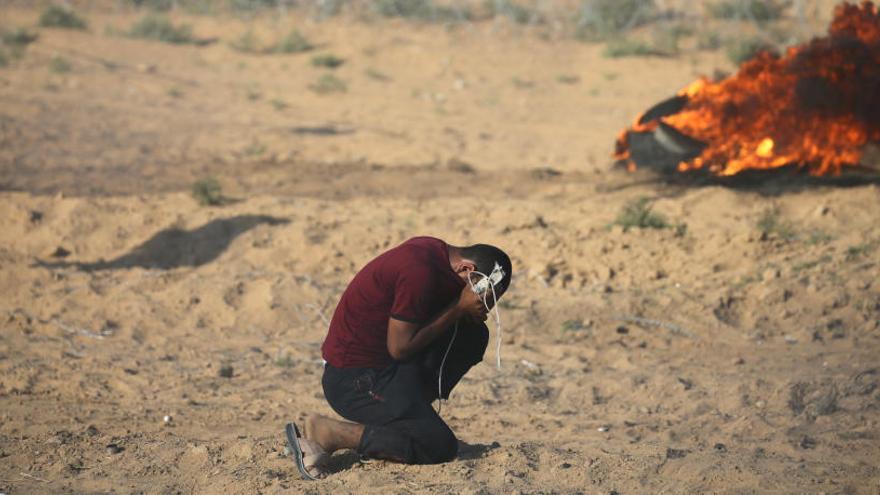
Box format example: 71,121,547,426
0,4,880,494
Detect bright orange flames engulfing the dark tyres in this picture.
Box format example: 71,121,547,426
615,1,880,176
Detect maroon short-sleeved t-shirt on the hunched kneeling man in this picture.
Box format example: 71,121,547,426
321,237,465,368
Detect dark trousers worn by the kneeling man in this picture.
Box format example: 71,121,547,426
322,322,489,464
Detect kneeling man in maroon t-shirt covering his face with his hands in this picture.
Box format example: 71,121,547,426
288,237,511,477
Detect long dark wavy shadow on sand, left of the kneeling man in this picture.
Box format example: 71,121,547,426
35,215,289,272
